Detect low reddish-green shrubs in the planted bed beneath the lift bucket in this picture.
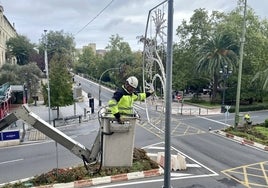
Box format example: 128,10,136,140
3,148,159,188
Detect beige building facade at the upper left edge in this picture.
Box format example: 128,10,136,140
0,5,17,68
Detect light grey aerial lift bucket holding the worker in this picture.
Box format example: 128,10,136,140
101,111,137,167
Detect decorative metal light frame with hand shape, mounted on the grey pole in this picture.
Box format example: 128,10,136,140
140,0,168,125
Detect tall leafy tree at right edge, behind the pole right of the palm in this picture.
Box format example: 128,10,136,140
217,0,268,101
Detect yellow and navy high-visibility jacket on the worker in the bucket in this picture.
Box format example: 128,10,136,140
108,85,151,118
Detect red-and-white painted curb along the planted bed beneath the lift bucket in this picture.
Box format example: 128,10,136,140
34,167,164,188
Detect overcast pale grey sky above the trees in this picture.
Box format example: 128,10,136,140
0,0,268,50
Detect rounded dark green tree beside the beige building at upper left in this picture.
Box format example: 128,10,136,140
6,35,34,65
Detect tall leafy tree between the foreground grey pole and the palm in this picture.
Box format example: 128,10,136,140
173,9,224,93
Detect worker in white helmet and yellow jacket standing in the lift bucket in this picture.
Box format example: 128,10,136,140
108,76,154,124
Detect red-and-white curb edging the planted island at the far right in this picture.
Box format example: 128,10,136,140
213,130,268,151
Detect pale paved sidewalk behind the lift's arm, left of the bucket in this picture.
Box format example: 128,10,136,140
4,92,98,143
